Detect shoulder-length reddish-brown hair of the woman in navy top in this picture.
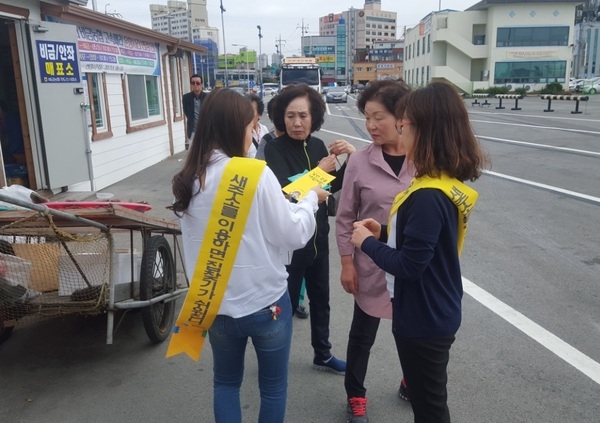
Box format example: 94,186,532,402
396,81,489,181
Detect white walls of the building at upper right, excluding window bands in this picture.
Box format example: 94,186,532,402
404,3,575,92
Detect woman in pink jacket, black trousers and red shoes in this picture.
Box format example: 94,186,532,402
335,81,415,423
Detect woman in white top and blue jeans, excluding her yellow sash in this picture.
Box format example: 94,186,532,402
172,89,328,423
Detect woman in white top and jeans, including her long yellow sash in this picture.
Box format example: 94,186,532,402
167,89,328,423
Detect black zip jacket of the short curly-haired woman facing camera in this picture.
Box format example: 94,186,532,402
265,134,346,266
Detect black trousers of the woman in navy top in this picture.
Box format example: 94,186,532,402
394,335,454,423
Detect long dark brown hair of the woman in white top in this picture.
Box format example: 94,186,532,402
170,89,254,214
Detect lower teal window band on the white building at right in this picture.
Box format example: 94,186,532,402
494,60,567,84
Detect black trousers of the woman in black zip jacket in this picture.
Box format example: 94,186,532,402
286,254,331,360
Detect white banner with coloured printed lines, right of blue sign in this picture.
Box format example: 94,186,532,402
77,26,160,75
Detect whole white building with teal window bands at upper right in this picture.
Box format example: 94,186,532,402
404,0,581,93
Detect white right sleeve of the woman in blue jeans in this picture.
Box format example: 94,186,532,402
256,167,318,251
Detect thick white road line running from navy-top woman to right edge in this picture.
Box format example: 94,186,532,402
462,277,600,385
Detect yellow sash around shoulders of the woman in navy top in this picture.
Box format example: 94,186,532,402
388,172,479,255
